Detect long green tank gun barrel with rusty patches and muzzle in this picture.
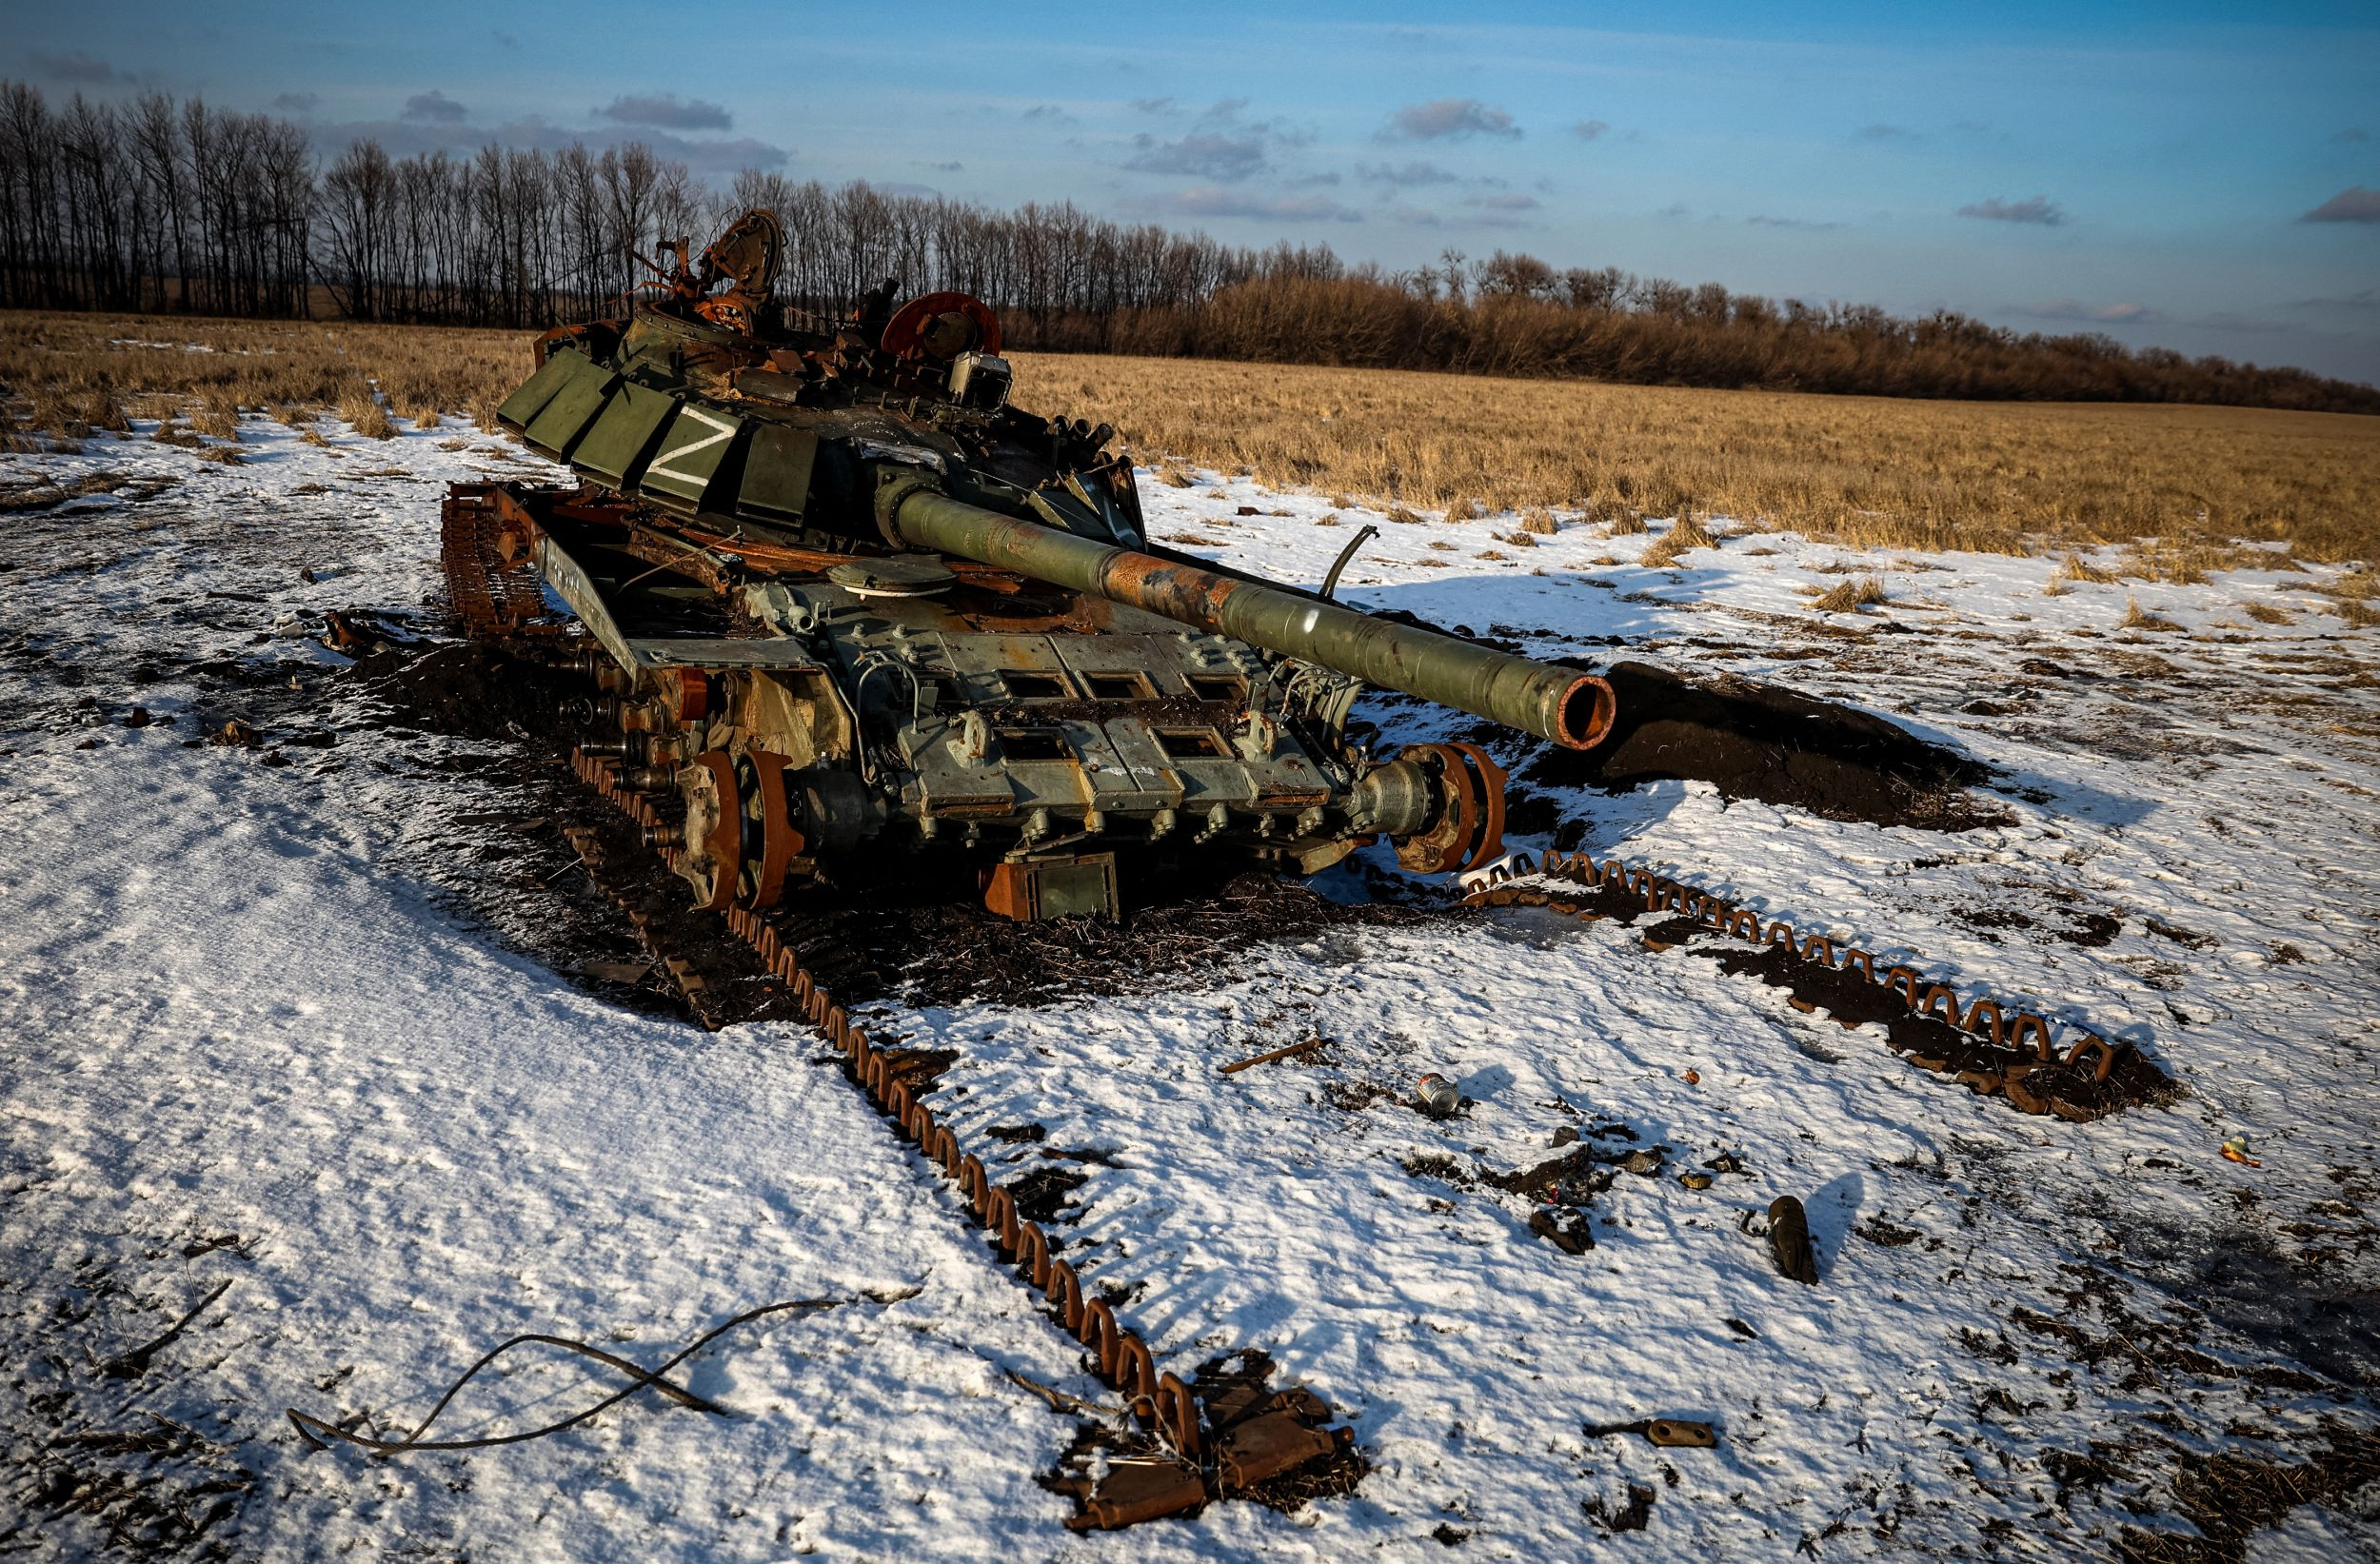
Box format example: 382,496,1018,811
876,474,1616,750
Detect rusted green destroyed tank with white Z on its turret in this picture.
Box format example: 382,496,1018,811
446,212,1614,919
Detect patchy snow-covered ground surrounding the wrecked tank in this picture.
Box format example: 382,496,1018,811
0,419,2380,1559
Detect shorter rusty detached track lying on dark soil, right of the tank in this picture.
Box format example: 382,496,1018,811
1464,852,2173,1123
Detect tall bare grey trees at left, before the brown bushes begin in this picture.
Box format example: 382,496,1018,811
0,84,1340,346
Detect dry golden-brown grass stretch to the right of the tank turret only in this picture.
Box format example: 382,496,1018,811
1017,355,2380,560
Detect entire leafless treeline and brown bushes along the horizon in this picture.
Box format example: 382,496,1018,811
0,84,2380,412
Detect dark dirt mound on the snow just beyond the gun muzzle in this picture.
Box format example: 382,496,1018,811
1521,662,2004,831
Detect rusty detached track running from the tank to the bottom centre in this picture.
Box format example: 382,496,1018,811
565,750,1361,1531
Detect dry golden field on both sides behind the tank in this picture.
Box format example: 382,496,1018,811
0,314,2380,564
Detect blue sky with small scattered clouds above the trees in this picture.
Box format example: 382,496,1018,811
18,0,2380,381
